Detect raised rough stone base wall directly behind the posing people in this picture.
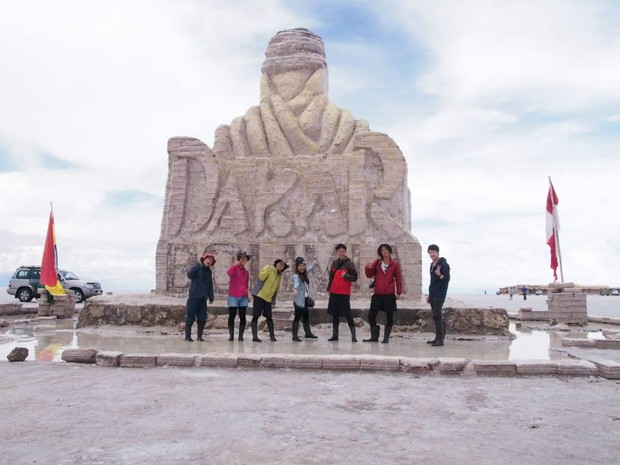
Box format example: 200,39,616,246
77,299,510,336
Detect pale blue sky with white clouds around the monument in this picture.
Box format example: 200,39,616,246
0,0,620,293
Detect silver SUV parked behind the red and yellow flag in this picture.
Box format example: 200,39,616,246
6,265,103,304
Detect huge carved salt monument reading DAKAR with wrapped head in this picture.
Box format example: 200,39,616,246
156,29,422,301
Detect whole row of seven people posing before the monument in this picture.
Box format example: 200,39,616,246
185,244,450,346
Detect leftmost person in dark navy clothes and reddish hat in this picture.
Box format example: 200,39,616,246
185,253,215,342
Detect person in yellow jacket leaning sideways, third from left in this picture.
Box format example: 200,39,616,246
252,259,288,342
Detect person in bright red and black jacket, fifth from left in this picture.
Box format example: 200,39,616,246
327,244,357,342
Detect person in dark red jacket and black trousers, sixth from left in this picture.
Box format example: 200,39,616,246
364,244,403,344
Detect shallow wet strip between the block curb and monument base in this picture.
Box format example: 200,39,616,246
0,318,603,362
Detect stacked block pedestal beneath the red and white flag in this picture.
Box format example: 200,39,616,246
547,283,588,325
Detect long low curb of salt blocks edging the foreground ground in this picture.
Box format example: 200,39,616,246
61,349,620,379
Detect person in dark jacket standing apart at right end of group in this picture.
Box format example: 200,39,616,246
426,244,450,347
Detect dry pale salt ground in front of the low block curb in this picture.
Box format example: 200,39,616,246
0,362,620,465
